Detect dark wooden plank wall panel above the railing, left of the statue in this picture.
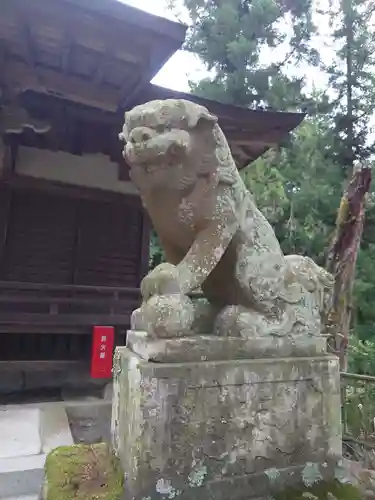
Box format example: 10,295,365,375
0,187,143,287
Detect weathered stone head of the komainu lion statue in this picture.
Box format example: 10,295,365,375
120,99,226,190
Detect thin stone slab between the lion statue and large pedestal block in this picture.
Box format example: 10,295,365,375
126,331,327,363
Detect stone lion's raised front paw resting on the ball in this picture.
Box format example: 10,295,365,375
141,262,181,301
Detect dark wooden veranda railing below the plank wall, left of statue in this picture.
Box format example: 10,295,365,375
0,281,140,334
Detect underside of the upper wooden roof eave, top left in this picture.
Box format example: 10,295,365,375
0,0,186,112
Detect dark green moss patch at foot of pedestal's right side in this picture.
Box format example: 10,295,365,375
274,481,363,500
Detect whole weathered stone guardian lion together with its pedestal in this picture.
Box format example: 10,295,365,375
117,99,341,500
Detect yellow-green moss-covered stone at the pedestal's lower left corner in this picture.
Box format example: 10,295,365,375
44,443,124,500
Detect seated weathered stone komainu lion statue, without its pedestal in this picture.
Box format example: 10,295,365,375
120,99,333,338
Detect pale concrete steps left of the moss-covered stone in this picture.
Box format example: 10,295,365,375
0,405,73,500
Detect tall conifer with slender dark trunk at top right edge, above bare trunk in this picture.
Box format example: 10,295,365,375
324,0,375,170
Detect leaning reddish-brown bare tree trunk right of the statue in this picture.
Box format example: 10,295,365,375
326,167,371,371
